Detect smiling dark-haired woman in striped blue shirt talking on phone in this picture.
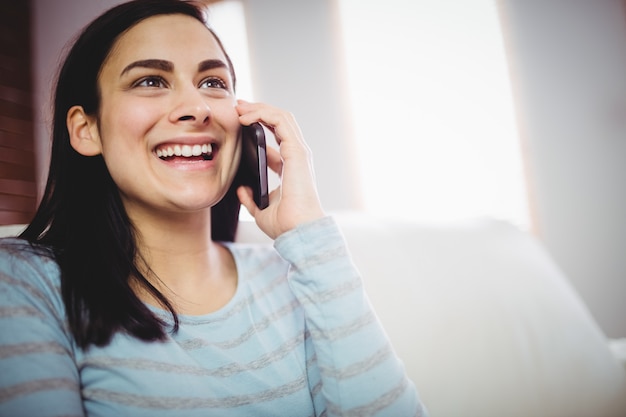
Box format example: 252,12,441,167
0,0,424,417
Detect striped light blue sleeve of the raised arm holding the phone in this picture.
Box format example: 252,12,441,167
274,217,427,417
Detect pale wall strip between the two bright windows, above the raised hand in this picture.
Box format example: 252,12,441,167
244,0,361,210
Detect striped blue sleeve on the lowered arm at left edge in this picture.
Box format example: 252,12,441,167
0,241,84,417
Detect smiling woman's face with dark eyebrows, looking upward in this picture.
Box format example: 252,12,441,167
92,15,241,219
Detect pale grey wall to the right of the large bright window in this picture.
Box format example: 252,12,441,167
499,0,626,337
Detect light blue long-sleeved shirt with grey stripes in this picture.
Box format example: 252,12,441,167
0,217,426,417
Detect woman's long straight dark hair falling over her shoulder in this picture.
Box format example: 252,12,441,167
20,0,240,348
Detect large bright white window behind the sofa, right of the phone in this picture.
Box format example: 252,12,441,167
338,0,529,228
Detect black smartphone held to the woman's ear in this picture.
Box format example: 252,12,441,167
239,123,270,210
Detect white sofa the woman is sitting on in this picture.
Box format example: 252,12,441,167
0,213,626,417
